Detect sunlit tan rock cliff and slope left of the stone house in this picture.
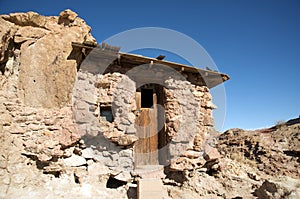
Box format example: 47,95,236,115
0,10,126,198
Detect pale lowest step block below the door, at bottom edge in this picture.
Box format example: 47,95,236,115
137,178,166,199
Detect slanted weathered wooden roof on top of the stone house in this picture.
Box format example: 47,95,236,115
72,43,230,88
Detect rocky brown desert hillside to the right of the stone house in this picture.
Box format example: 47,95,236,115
164,118,300,198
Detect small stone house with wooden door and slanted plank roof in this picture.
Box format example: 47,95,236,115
69,43,229,172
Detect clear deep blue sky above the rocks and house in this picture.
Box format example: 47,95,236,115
0,0,300,130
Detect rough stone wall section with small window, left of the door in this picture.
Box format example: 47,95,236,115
73,71,137,176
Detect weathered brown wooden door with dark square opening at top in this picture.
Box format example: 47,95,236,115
134,89,159,167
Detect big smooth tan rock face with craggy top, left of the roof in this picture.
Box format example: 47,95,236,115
0,10,95,108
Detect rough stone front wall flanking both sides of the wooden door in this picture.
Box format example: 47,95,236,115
73,71,215,171
